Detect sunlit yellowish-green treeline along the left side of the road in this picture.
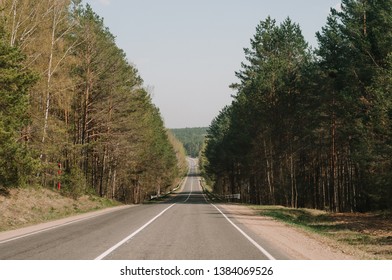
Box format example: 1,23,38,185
0,0,185,203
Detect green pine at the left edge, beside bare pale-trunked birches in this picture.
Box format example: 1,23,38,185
0,34,36,187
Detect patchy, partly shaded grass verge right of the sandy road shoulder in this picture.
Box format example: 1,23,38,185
250,206,392,259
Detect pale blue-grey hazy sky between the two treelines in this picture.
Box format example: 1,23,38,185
85,0,340,128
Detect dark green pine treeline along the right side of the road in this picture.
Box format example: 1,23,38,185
202,0,392,212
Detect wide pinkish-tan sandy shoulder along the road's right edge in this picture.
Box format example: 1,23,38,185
220,204,367,260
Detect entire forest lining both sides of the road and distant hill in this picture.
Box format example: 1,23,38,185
0,0,392,212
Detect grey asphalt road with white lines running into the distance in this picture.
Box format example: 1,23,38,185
0,160,287,260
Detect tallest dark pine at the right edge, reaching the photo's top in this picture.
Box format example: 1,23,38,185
317,0,392,211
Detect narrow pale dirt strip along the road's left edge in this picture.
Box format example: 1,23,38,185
0,205,137,243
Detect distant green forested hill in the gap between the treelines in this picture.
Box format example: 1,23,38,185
170,127,208,157
